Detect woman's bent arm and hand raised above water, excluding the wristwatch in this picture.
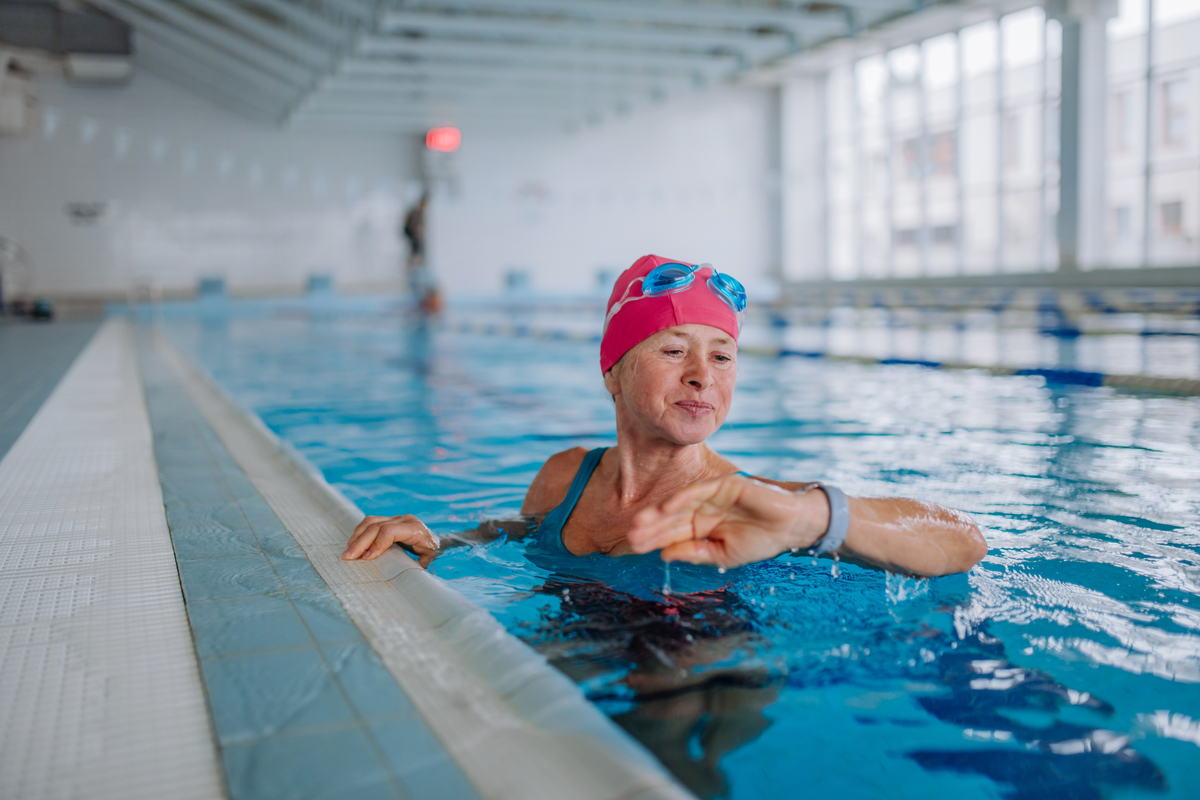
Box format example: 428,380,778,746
629,475,988,576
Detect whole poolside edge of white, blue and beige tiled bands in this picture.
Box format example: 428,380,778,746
0,320,689,800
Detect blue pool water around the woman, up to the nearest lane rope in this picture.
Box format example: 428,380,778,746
168,303,1200,800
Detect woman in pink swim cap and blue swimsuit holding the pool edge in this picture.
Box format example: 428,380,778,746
342,255,988,576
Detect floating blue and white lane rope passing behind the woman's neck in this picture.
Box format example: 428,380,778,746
451,323,1200,395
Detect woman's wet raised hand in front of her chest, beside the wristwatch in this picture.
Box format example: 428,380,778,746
629,475,829,567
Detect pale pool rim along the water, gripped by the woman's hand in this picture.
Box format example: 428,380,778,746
155,332,692,800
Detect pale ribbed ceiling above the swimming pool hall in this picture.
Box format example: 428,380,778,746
89,0,925,132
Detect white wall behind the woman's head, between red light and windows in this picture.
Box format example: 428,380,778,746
430,88,778,294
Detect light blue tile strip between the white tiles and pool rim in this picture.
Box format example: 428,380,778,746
137,330,468,800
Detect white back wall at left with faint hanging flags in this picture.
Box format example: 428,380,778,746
0,72,416,294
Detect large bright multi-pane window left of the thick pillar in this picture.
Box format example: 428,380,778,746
826,8,1060,278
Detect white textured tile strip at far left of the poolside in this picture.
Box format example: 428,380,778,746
0,320,224,800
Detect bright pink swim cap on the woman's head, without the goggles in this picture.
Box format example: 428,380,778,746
600,255,738,373
